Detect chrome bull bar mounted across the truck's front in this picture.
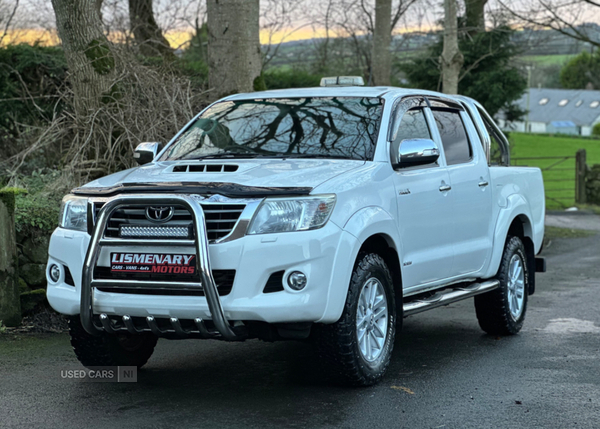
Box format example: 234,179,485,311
80,194,243,341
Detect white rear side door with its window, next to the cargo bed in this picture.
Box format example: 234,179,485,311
432,107,492,277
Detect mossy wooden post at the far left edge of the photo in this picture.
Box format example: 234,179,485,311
0,189,21,326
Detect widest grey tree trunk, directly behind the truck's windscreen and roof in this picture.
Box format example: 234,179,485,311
206,0,262,98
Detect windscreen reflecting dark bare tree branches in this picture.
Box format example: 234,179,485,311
161,97,383,161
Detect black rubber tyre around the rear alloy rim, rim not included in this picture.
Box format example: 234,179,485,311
475,236,529,336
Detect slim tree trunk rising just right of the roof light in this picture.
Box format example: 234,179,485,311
372,0,392,85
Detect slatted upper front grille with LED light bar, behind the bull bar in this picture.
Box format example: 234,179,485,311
94,203,246,242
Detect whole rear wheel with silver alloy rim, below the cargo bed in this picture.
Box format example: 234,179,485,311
475,237,529,335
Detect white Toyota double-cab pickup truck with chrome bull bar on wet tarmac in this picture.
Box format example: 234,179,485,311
47,79,545,385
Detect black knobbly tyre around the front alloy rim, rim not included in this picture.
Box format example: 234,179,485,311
316,253,396,386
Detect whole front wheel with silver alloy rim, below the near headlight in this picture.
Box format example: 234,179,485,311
317,253,396,386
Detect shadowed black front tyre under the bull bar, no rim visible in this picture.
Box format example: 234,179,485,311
68,316,158,368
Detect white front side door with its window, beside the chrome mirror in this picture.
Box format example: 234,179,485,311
390,103,454,290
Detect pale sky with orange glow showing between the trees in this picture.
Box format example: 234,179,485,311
0,0,600,48
